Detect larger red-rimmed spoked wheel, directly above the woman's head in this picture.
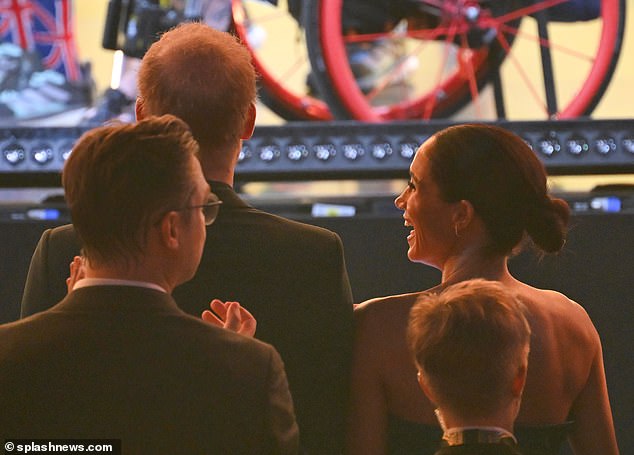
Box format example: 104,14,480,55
305,0,625,121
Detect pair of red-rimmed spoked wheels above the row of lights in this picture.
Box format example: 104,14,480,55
232,0,625,122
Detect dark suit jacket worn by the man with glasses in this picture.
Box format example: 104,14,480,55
0,286,299,455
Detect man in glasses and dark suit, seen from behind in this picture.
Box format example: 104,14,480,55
0,115,299,454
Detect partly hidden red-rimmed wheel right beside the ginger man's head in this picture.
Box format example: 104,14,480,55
232,0,332,120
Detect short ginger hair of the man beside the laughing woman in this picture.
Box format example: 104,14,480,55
138,23,256,153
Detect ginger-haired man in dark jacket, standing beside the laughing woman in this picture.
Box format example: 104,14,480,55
21,23,352,453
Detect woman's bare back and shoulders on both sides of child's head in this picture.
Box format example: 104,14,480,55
352,276,616,454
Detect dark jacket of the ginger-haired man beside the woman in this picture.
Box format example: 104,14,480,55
21,182,352,453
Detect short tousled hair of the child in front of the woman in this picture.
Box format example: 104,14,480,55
407,279,531,418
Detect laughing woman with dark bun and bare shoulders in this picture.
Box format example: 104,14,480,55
348,124,618,455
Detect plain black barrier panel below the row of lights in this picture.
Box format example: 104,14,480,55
0,213,634,454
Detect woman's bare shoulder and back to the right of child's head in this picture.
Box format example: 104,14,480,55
513,282,618,454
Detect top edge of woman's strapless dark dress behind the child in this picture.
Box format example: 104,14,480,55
387,415,572,455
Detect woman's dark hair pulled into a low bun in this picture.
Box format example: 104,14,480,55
427,124,570,254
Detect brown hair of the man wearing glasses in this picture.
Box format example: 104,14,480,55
62,115,198,264
